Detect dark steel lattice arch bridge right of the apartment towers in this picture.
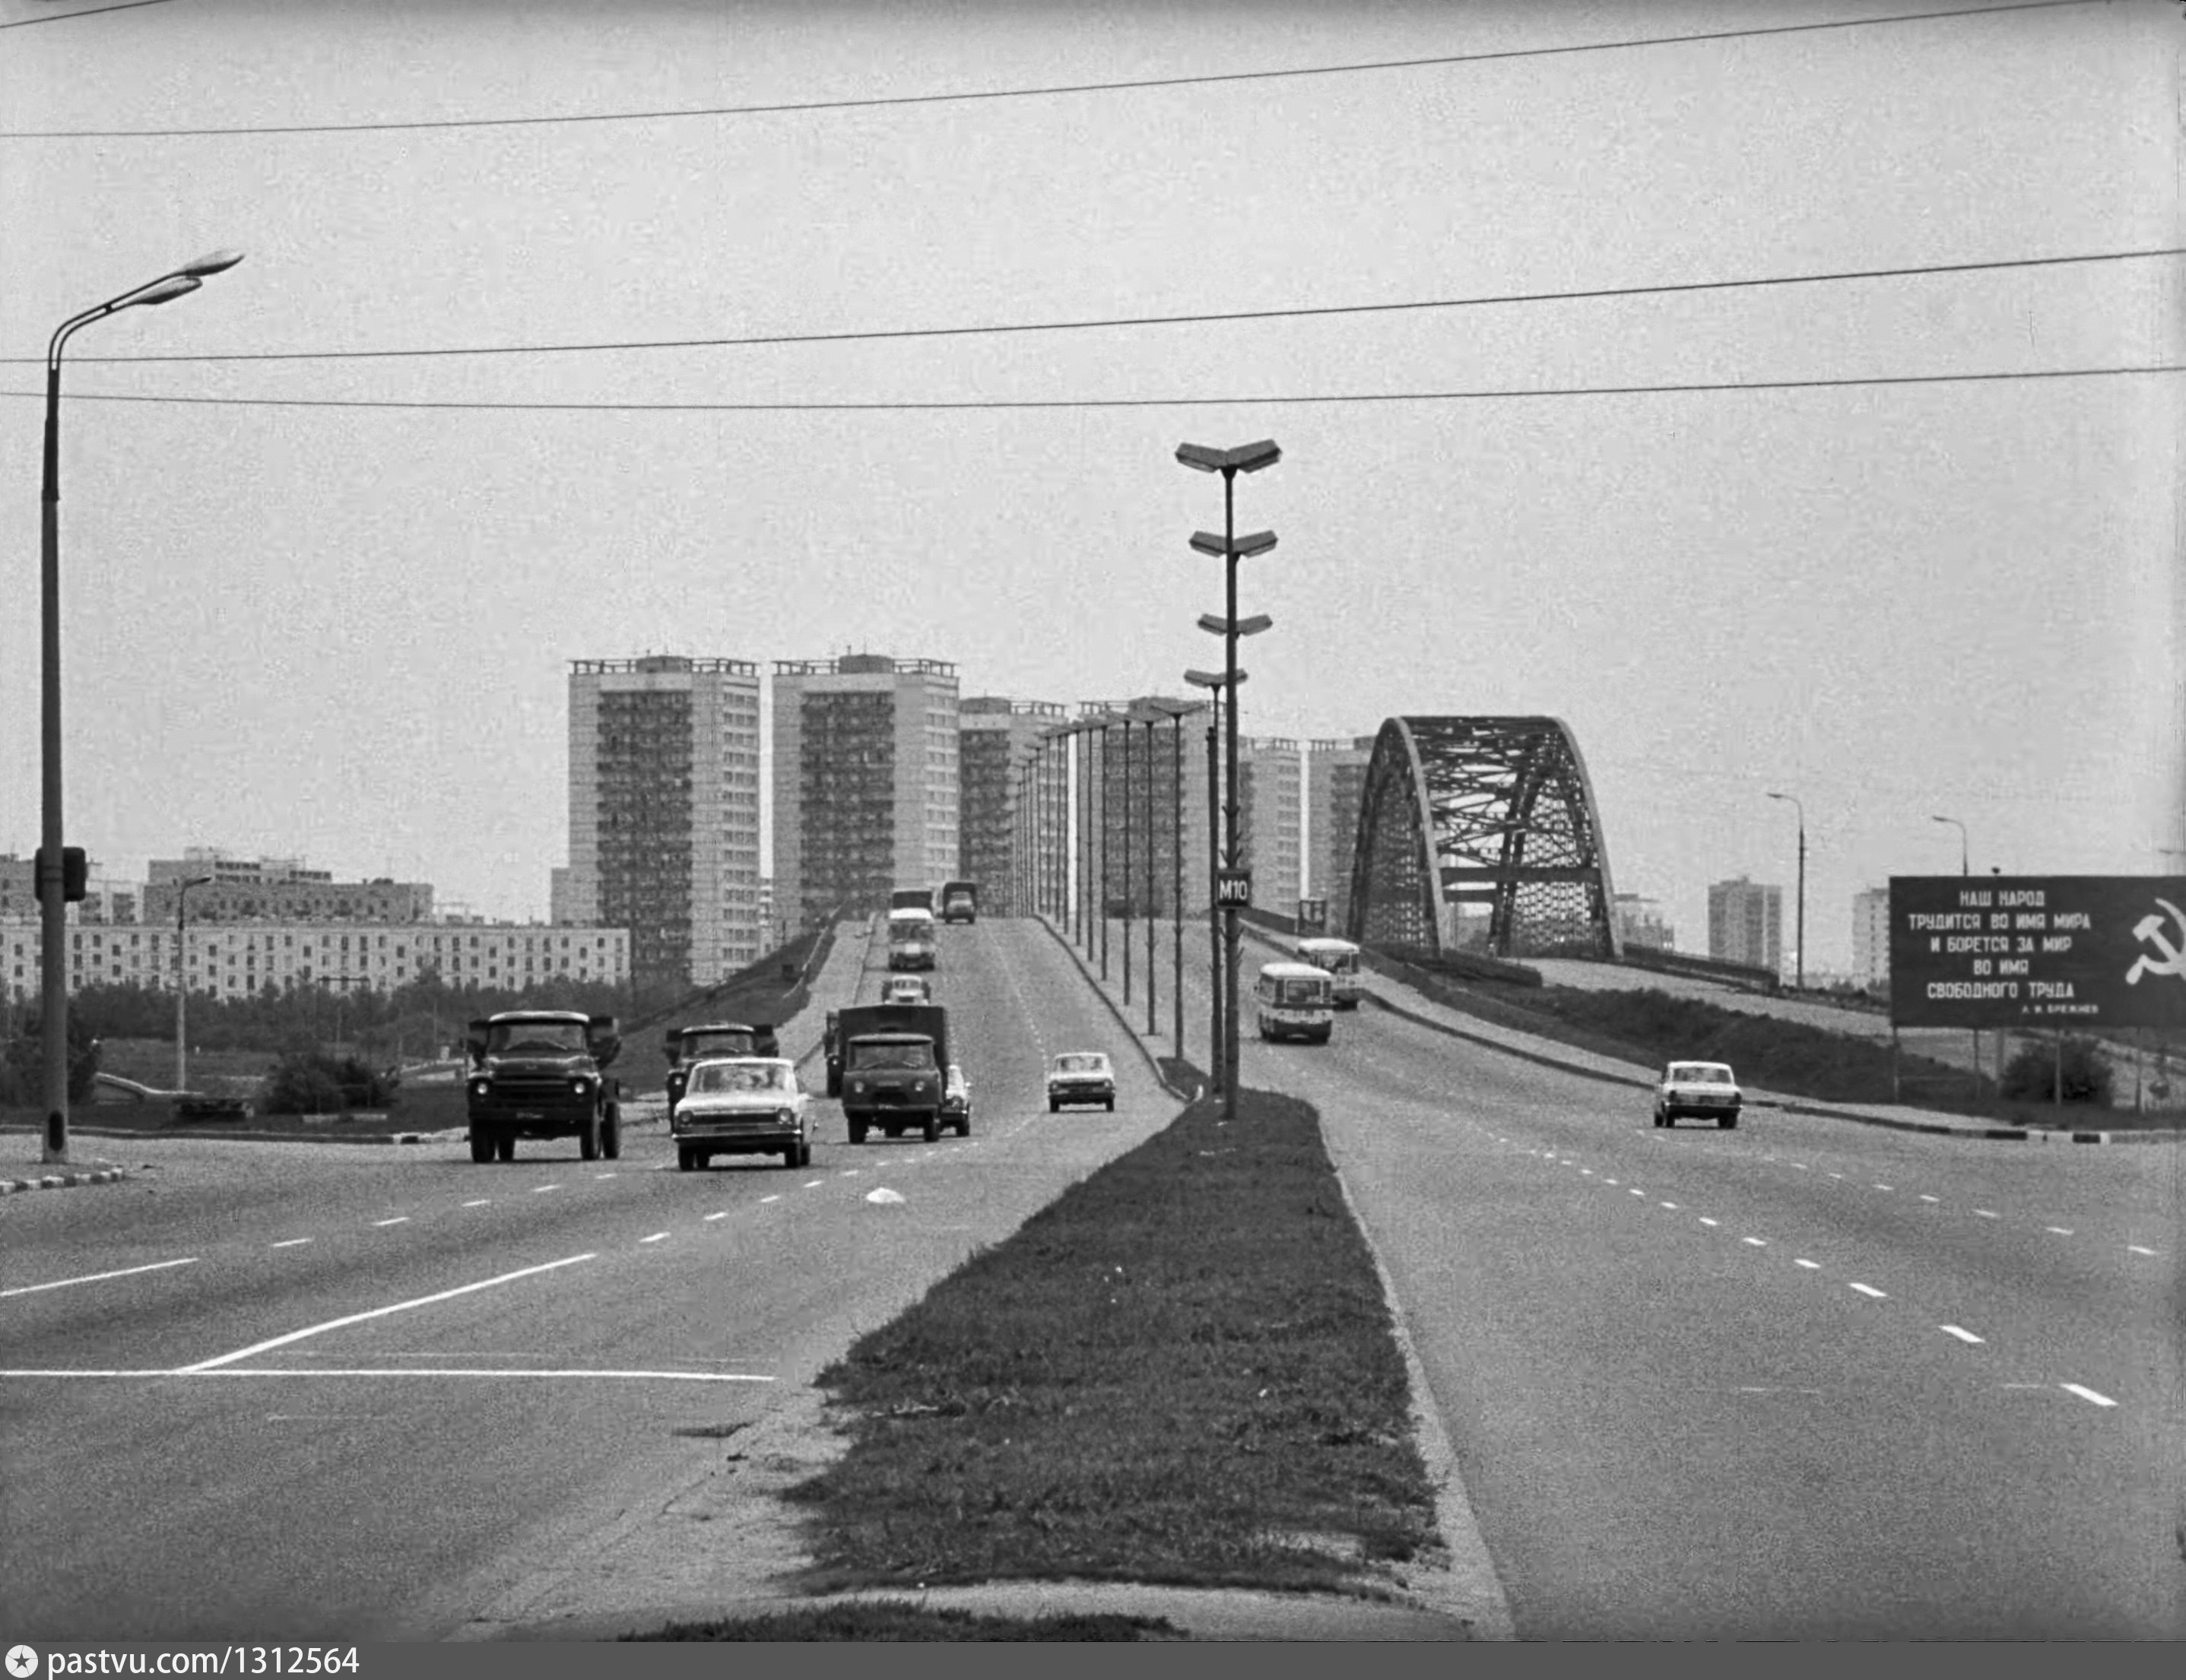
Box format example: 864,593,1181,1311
1347,717,1624,961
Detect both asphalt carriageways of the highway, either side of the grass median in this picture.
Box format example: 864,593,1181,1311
0,920,2186,1638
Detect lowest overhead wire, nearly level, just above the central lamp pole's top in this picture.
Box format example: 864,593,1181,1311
0,363,2186,415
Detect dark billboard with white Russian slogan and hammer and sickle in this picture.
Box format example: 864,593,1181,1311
1891,876,2186,1027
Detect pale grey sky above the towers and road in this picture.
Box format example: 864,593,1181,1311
0,0,2186,970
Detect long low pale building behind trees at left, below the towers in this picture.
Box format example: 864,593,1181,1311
0,908,630,1000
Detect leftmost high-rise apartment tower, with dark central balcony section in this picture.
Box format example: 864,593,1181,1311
551,653,763,985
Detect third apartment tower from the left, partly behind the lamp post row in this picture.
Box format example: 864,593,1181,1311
953,695,1069,915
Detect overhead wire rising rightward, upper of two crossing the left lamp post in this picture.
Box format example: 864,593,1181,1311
25,245,2186,365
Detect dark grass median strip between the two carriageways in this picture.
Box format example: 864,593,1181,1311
792,1092,1436,1590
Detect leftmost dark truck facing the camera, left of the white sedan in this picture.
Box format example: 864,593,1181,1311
464,1010,623,1162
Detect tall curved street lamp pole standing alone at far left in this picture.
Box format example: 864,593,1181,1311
37,251,243,1162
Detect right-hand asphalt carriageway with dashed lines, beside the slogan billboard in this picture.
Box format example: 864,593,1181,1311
1194,935,2186,1640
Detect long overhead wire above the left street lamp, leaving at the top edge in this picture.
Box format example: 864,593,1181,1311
0,0,2109,140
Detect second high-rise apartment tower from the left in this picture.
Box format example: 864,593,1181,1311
774,653,962,927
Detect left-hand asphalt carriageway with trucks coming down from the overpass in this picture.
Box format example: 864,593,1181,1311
0,920,1174,1640
